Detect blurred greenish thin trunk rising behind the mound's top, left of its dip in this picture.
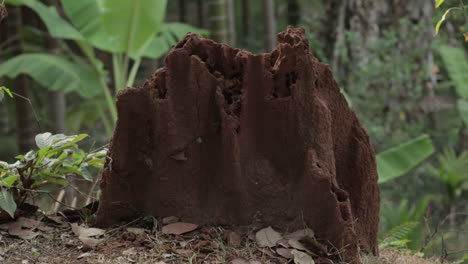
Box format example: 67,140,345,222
206,0,229,43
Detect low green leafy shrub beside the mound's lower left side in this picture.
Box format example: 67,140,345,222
0,132,107,217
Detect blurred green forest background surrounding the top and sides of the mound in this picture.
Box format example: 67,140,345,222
0,0,468,263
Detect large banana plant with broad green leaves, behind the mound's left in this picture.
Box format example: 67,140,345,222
0,0,207,134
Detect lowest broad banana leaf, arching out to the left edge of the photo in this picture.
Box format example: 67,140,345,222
0,53,102,98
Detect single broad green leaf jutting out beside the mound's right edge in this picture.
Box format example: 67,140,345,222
376,135,434,184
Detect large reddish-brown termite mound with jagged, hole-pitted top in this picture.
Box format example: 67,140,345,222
97,28,380,263
